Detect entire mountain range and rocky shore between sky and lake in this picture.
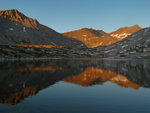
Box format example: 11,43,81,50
0,9,150,59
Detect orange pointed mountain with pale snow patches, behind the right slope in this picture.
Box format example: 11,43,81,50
109,25,142,40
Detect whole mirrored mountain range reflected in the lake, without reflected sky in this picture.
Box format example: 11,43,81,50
0,59,150,105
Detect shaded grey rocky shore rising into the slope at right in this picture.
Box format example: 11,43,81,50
0,25,150,59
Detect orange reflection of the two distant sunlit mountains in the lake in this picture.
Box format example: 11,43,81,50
64,67,140,89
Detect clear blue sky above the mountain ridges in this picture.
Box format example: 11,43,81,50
0,0,150,33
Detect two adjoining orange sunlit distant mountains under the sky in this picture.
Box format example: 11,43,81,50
63,25,142,48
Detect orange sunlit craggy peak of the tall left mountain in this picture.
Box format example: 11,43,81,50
0,9,38,28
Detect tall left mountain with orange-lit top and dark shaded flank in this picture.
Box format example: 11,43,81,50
0,9,84,47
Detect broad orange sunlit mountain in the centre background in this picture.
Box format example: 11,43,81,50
62,28,118,48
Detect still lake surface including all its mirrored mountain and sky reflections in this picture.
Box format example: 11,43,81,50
0,59,150,113
